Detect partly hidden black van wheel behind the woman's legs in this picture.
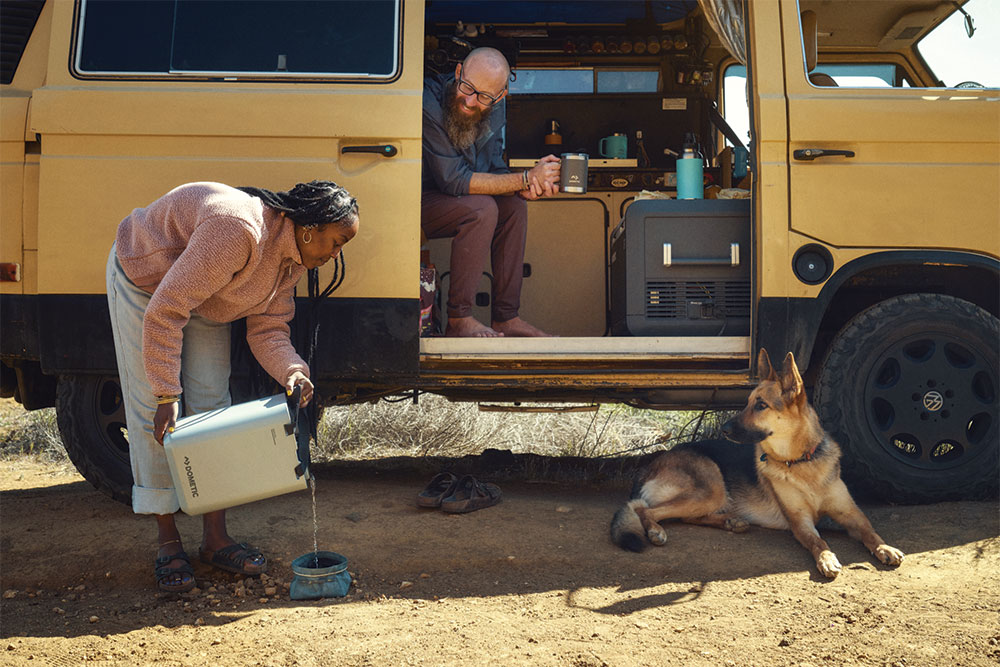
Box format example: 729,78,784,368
56,375,132,504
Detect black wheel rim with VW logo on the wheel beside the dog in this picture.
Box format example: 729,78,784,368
864,332,998,470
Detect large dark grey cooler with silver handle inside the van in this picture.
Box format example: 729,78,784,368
611,199,750,336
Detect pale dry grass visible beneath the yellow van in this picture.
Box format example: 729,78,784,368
0,394,726,466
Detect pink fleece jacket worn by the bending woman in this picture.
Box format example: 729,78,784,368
116,183,309,396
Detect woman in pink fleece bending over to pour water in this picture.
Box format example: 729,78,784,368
107,181,358,593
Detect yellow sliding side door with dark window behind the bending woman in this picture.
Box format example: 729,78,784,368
30,0,423,381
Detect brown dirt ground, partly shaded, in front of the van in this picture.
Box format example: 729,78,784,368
0,459,1000,667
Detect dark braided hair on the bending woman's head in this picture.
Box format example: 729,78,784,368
237,181,358,227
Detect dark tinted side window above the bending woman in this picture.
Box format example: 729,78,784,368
76,0,400,79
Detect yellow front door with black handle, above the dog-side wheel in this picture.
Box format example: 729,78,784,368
781,1,1000,256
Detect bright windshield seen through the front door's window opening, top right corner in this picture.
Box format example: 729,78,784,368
917,0,1000,88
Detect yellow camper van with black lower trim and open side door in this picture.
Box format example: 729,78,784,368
0,0,1000,501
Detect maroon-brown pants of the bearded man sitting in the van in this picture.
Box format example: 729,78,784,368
420,191,528,322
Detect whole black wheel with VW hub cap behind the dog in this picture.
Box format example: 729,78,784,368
815,294,1000,503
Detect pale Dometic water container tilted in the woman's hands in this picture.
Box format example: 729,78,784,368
163,392,307,514
